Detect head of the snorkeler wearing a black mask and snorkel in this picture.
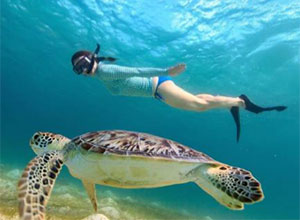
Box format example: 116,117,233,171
71,44,116,74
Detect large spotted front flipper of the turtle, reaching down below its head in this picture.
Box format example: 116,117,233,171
18,151,63,220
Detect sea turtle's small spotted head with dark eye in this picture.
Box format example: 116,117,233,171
29,132,70,155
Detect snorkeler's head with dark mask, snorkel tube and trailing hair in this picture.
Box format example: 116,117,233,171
73,44,116,74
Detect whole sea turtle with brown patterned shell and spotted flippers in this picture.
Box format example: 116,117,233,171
18,130,264,220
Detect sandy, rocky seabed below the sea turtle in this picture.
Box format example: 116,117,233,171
0,162,211,220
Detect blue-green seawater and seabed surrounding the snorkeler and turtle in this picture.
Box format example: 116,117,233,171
0,0,300,219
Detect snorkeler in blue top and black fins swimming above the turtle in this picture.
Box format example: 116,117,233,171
71,44,287,141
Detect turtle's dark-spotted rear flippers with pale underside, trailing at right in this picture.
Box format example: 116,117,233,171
193,164,264,210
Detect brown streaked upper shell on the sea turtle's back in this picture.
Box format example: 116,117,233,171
72,130,214,162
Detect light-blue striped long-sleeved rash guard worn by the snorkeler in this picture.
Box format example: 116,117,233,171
95,63,168,97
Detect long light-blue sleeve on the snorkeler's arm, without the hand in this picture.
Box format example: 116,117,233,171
96,64,169,80
